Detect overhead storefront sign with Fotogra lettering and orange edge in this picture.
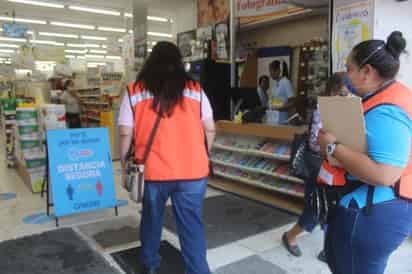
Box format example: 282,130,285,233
237,0,304,25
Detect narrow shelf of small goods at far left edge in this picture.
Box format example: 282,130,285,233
1,98,16,167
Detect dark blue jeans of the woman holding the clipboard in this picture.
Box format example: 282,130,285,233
326,199,412,274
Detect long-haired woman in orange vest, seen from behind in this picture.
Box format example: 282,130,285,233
119,42,215,274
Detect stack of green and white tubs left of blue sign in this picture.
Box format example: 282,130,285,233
16,107,46,193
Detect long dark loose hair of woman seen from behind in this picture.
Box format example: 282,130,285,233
136,42,192,116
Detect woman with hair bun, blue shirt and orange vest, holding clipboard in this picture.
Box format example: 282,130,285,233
318,32,412,274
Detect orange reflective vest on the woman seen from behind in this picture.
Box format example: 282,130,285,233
129,81,209,181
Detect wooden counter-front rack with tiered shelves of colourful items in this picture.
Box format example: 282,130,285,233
210,121,305,213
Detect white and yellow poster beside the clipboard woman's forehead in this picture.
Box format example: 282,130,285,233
332,0,373,72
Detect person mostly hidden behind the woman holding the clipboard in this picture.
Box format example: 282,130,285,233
282,73,349,261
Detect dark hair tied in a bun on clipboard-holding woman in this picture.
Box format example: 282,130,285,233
352,31,406,79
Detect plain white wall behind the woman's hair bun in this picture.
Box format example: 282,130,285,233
374,0,412,88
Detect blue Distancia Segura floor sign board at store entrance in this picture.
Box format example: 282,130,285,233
47,128,117,217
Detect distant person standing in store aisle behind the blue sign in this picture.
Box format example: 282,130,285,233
61,79,81,128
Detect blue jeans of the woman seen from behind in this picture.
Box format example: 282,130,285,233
140,179,210,274
